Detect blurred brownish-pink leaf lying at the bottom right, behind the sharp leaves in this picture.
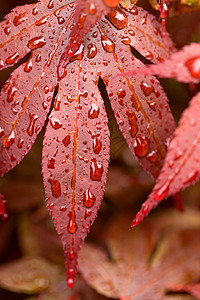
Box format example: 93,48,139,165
79,211,200,300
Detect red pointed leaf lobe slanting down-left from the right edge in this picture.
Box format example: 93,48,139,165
131,93,200,228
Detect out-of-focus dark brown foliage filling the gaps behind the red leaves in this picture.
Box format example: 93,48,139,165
0,0,200,300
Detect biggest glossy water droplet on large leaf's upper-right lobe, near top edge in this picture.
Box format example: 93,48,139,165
106,8,128,30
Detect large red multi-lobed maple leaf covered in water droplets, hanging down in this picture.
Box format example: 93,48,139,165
0,0,175,287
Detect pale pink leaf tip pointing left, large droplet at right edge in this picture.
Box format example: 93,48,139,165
124,43,200,83
